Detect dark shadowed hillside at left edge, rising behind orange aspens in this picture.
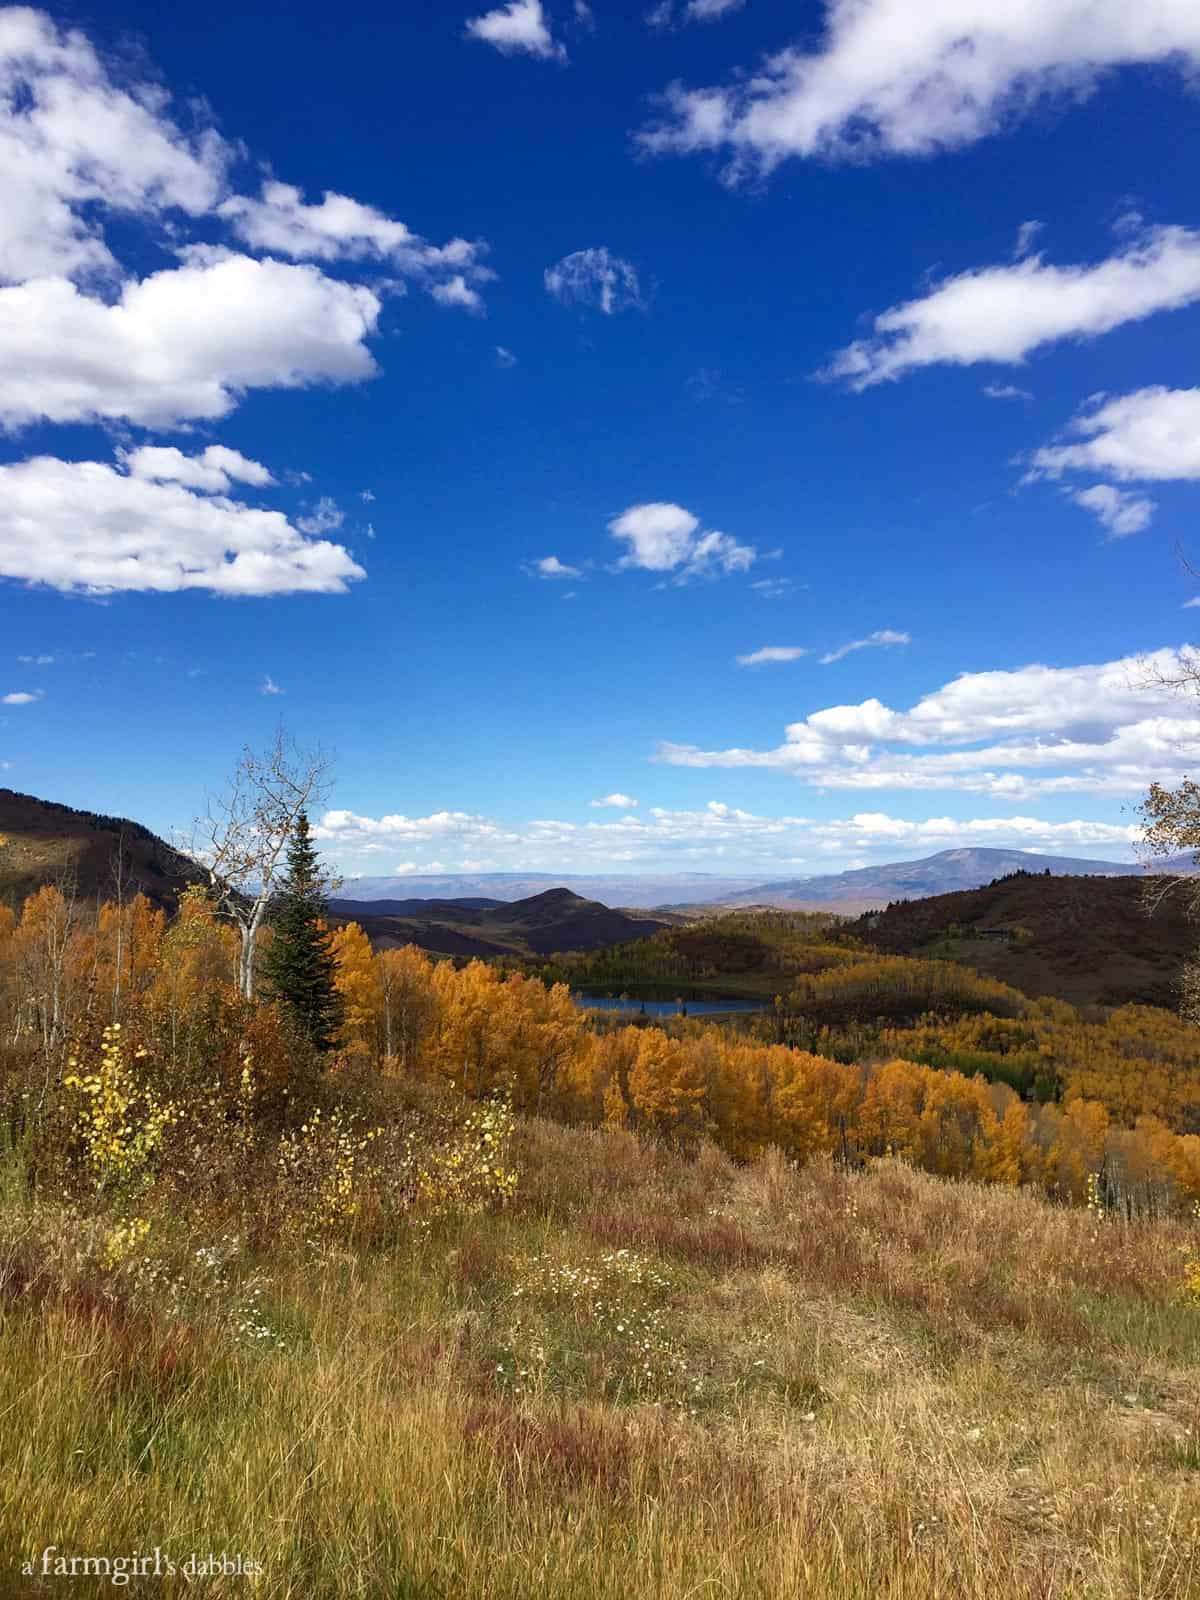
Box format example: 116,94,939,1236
0,789,200,909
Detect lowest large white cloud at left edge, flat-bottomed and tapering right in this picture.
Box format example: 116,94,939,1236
0,456,365,595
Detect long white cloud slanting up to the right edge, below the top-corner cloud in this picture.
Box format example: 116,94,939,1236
824,227,1200,390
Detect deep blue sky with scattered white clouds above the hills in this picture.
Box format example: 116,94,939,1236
0,0,1200,877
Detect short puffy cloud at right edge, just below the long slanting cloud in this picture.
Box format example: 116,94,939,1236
1030,389,1200,482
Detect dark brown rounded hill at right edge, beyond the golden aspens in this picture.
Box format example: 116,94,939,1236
850,874,1200,1006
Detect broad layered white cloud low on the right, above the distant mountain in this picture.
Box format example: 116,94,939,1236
659,646,1200,800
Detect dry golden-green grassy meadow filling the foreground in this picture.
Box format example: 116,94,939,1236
0,1122,1200,1600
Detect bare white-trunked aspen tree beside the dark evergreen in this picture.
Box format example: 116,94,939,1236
190,728,330,1000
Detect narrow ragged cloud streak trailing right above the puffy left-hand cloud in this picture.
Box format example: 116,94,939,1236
218,179,494,310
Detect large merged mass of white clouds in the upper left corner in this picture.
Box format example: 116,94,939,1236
0,6,493,464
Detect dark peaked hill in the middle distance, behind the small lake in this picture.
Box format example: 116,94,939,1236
330,888,678,960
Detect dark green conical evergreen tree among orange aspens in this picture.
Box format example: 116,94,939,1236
262,811,342,1050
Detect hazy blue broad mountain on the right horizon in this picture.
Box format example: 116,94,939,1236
704,850,1197,914
